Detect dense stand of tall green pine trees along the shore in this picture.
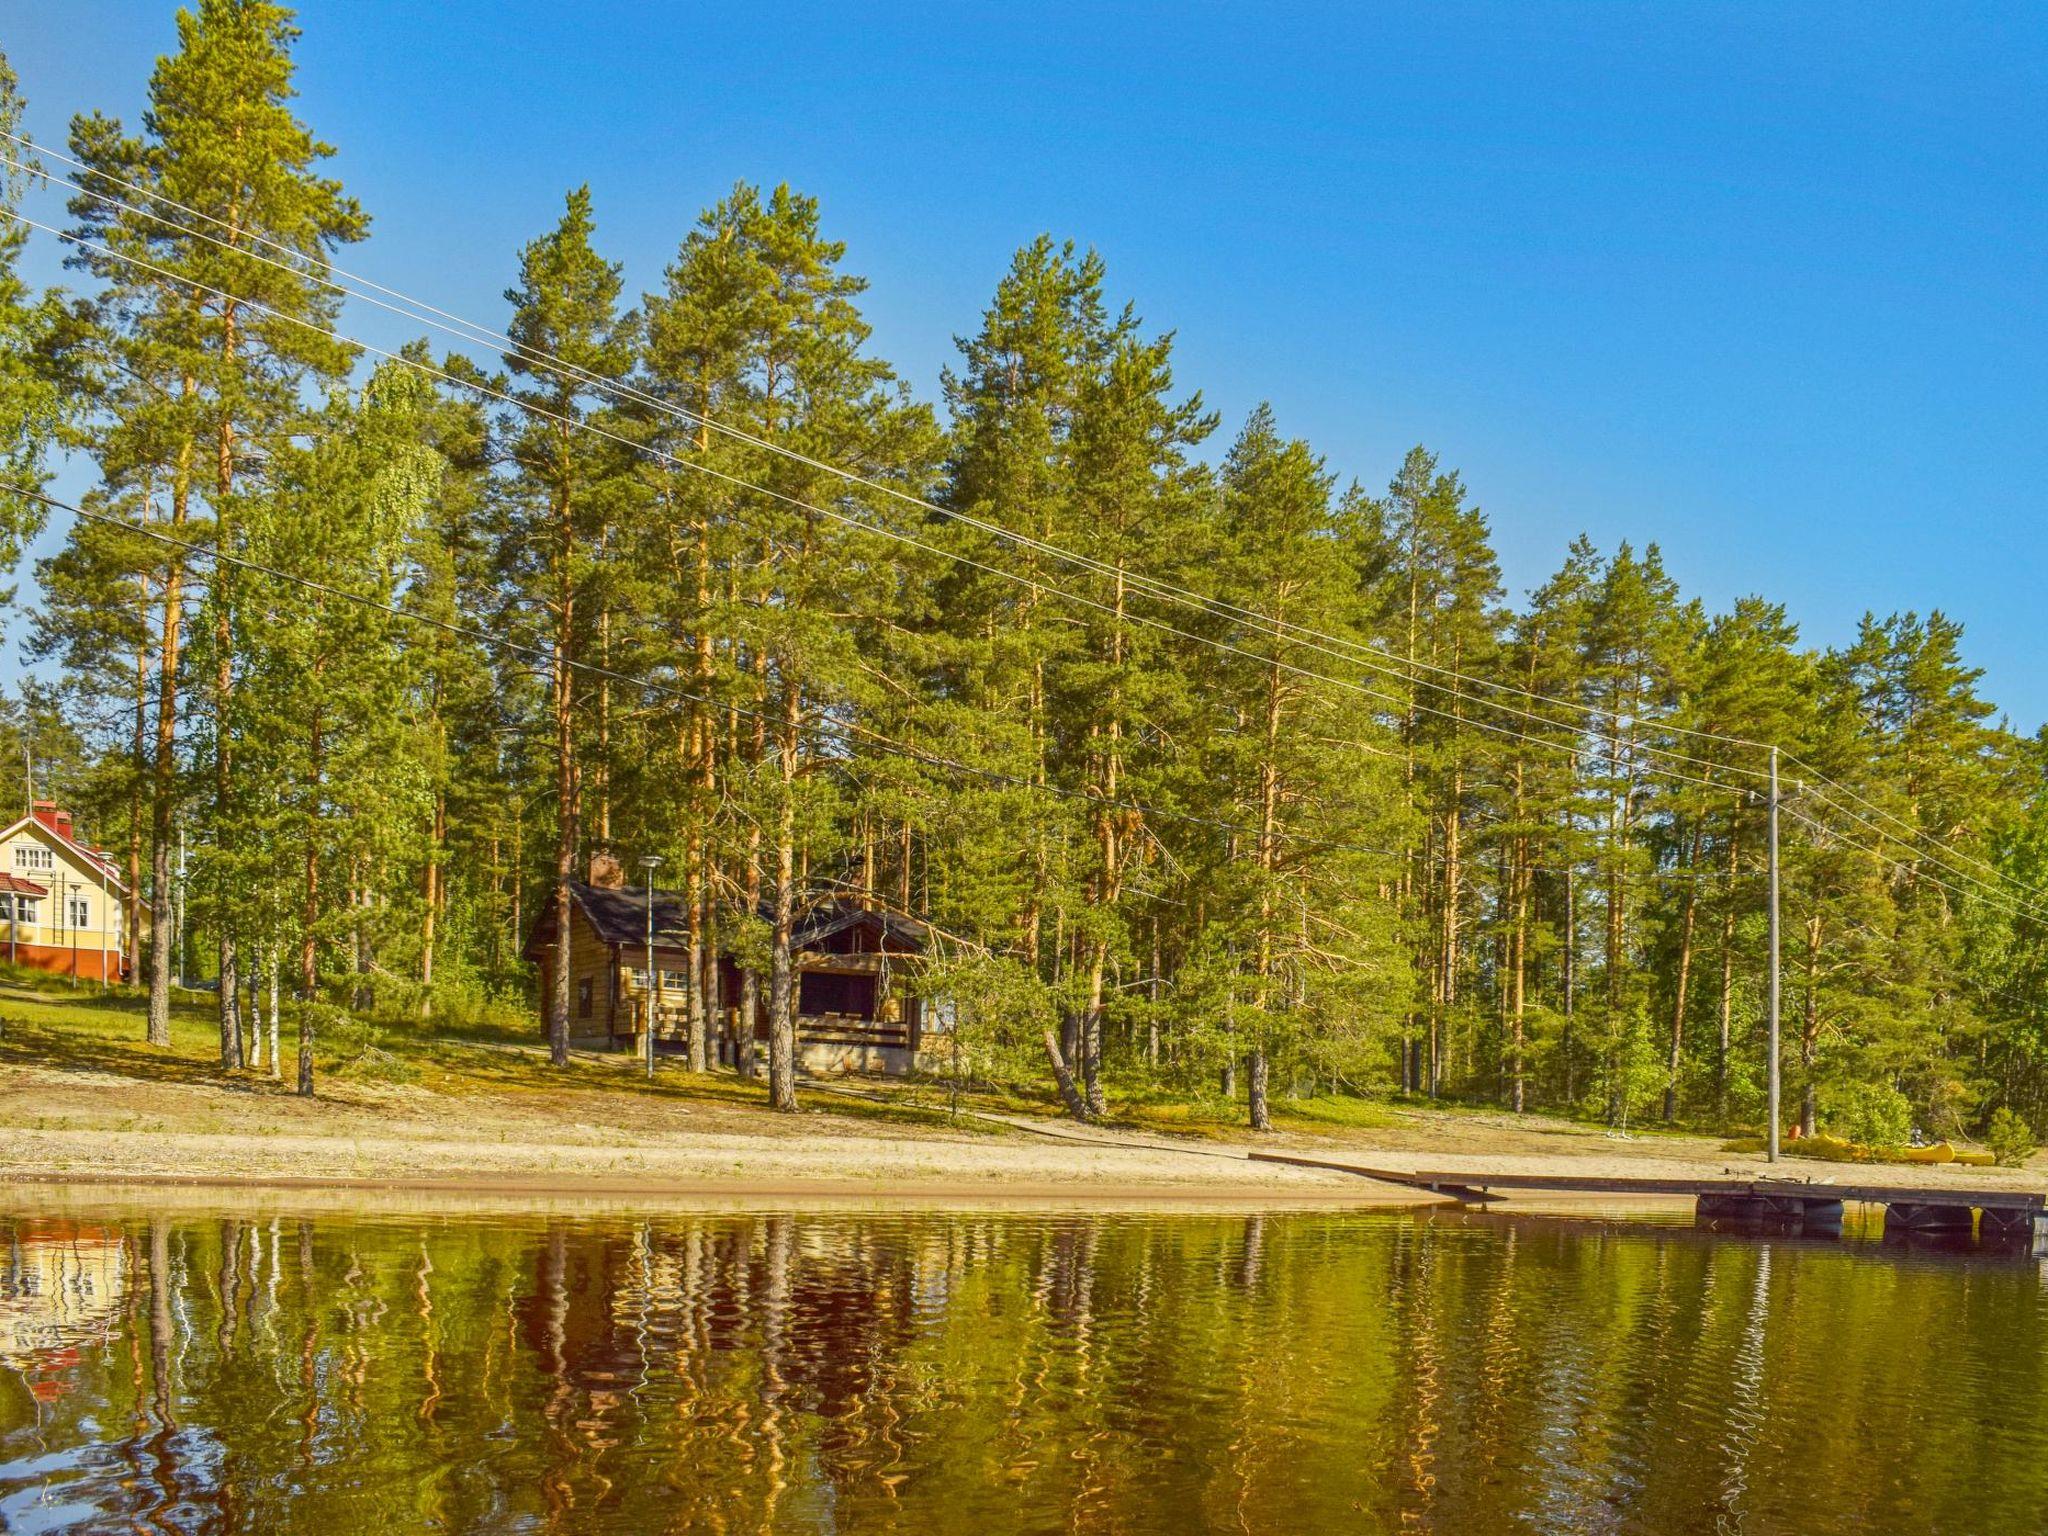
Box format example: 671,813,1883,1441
0,0,2048,1130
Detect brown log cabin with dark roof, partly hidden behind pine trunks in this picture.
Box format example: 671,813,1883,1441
524,854,944,1075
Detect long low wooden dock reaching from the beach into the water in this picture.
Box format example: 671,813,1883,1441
1251,1151,2048,1247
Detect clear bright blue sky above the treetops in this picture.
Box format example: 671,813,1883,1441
0,0,2048,729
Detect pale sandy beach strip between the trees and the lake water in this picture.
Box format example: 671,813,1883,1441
0,1051,2038,1206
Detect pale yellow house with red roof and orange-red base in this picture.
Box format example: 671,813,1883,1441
0,801,147,981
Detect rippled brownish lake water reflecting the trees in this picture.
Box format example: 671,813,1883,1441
0,1188,2048,1536
